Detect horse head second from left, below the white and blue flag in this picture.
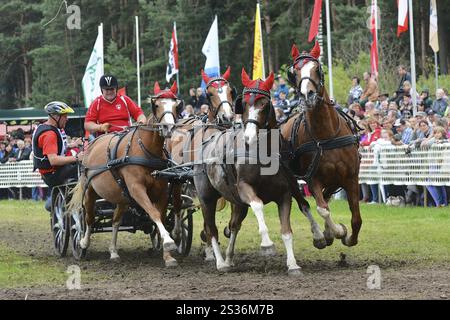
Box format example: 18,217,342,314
202,67,236,123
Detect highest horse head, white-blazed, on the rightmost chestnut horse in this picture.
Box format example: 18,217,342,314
288,41,324,109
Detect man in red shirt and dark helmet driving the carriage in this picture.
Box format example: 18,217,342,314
84,75,147,135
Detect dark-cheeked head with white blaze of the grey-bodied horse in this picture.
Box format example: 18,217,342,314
235,68,276,145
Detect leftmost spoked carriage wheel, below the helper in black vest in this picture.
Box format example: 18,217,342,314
50,188,69,257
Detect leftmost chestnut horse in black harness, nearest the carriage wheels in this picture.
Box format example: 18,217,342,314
69,82,180,267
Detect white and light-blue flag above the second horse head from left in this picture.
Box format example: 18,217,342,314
202,15,220,84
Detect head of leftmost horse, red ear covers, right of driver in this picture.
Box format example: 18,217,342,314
150,82,184,138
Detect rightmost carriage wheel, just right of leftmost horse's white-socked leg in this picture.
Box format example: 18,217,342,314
172,195,195,256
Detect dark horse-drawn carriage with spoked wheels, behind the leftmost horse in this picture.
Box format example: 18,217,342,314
50,164,198,260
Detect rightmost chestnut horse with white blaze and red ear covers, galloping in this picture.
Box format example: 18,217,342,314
282,42,362,248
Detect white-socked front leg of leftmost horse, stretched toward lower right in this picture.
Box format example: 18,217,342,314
129,183,178,267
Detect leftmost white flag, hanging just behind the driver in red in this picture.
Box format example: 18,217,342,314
81,25,104,108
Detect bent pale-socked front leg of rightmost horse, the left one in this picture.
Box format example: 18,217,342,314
312,180,347,245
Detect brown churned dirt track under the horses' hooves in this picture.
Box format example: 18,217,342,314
0,219,450,299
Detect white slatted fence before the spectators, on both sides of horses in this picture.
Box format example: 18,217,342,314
0,143,450,188
